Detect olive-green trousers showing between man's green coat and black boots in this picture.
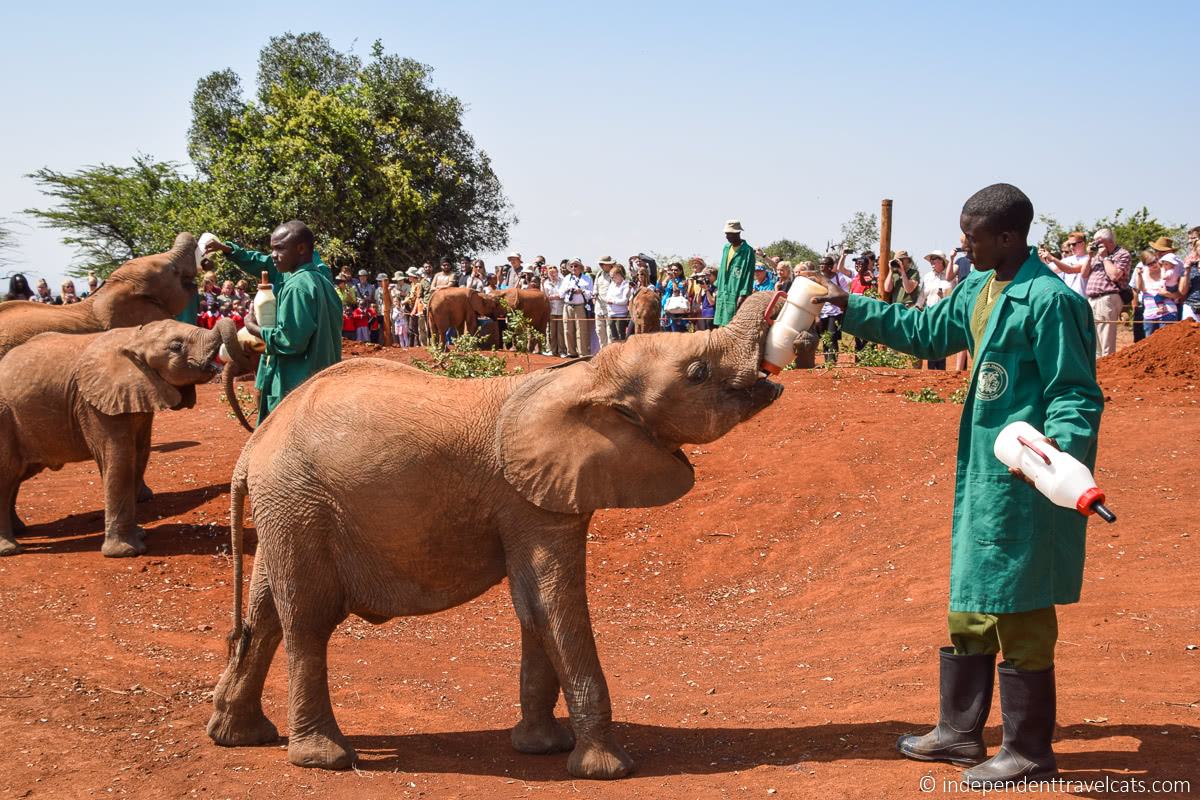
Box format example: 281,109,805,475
947,606,1058,672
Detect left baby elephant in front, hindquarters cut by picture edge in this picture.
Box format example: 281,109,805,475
0,319,248,557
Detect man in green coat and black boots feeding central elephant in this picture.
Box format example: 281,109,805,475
817,184,1104,788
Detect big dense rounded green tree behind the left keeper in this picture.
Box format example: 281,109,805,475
188,34,516,269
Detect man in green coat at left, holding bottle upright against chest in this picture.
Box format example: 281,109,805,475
208,219,342,425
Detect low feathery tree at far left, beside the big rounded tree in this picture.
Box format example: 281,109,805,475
25,155,205,277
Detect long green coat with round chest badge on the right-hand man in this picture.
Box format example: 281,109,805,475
842,248,1104,614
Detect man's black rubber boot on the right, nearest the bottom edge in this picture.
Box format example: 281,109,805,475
962,662,1058,789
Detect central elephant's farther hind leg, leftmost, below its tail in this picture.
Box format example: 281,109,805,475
208,561,283,747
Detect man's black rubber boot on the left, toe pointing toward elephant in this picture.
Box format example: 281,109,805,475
896,648,996,766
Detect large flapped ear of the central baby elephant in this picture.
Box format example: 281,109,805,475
496,363,695,513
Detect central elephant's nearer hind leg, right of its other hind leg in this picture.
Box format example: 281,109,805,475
280,564,356,770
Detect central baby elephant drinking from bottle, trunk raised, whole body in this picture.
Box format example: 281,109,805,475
208,294,782,778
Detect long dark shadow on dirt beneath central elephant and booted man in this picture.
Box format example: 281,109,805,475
349,720,1200,782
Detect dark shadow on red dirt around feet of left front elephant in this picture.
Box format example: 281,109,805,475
19,483,229,555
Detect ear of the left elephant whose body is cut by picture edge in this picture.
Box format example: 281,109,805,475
76,327,180,416
